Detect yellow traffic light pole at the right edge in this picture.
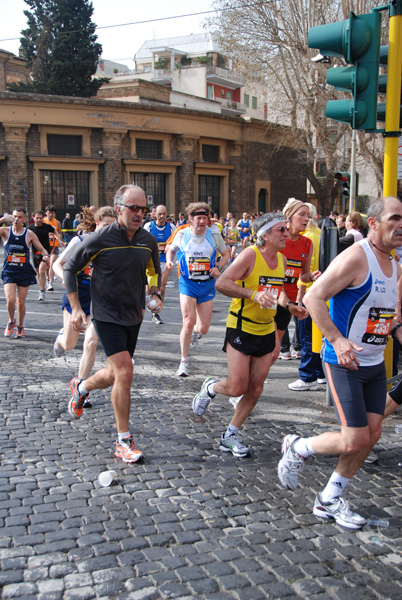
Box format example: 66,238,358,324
383,0,402,379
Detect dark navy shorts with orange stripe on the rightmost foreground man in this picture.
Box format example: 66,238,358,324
324,362,387,427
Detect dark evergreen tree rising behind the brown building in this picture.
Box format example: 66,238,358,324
8,0,108,97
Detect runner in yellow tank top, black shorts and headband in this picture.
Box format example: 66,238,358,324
193,213,302,458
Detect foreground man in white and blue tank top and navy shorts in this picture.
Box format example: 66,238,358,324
278,197,402,529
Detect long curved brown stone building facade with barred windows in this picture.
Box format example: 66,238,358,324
0,89,306,218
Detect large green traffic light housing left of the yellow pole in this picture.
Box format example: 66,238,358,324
308,10,381,131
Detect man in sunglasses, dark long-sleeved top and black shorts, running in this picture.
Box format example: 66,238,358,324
63,185,163,462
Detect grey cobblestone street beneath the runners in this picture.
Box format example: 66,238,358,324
0,275,402,600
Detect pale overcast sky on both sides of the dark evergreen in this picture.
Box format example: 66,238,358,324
0,0,217,68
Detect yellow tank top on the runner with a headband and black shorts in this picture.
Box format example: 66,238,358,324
226,246,285,335
